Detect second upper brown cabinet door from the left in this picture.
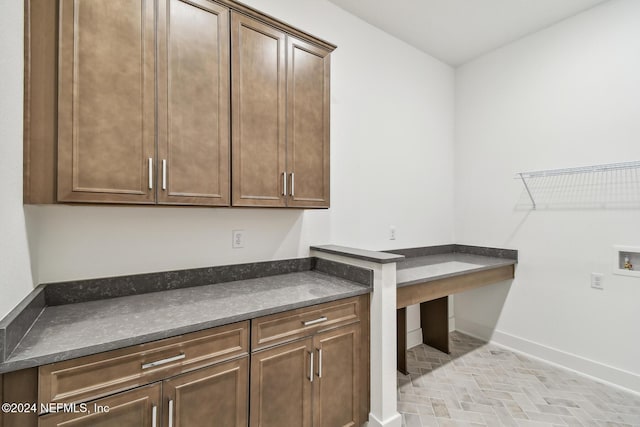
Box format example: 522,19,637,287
157,0,230,206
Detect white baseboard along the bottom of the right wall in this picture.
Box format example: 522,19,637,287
457,317,640,394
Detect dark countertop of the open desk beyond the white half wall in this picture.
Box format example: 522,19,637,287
396,252,517,288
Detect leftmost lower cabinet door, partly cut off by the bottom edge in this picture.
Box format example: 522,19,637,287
38,383,161,427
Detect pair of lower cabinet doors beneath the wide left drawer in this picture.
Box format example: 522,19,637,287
38,356,248,427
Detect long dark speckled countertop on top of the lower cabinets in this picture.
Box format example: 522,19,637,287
0,271,371,373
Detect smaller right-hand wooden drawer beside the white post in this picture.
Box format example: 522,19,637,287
251,297,360,351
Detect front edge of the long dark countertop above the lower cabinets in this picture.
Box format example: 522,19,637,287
0,284,373,374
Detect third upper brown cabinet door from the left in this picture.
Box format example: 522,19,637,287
231,12,286,207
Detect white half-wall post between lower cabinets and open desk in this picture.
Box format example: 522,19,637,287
311,250,402,427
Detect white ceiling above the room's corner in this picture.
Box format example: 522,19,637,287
330,0,608,66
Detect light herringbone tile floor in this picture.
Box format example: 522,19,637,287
398,332,640,427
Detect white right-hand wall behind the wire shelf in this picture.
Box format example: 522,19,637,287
455,0,640,391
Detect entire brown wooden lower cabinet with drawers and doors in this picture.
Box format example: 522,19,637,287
0,295,369,427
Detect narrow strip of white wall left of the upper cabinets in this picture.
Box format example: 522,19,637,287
0,0,33,317
